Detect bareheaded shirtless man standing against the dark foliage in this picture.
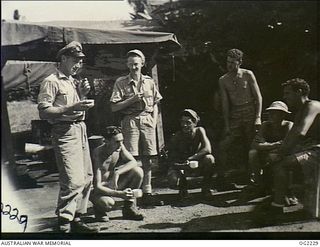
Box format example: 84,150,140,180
219,49,262,185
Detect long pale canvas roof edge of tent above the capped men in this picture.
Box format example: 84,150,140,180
1,21,180,49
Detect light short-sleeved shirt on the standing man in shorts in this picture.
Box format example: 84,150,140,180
110,75,162,115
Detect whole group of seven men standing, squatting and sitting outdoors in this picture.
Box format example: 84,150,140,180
38,41,320,233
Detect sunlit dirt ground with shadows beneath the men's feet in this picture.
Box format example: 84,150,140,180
1,162,320,233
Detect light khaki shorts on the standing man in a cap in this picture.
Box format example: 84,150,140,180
121,114,158,156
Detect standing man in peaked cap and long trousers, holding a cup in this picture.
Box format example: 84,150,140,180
38,41,98,233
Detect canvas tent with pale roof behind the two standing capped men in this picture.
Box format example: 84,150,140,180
1,21,180,168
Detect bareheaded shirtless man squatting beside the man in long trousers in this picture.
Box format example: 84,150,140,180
92,126,144,221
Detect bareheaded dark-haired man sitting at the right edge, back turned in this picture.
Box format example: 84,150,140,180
260,78,320,213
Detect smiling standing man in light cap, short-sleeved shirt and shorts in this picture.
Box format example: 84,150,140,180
110,50,163,206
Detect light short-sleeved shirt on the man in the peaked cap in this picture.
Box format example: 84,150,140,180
38,70,85,124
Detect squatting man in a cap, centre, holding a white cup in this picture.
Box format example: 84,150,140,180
168,109,215,198
